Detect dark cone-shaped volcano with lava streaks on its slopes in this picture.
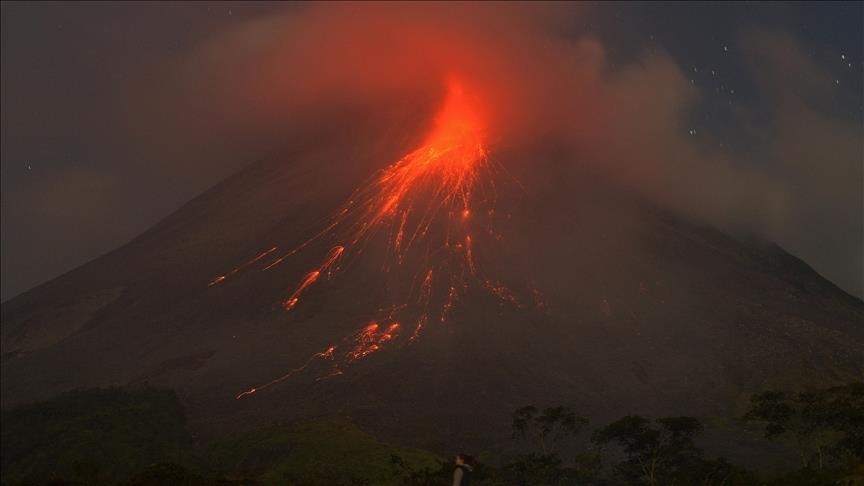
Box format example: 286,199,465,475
2,96,864,464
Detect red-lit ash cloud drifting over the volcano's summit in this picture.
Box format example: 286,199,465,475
4,3,864,297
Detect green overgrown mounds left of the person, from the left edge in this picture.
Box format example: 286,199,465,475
0,386,443,486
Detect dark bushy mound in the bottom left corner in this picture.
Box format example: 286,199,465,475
2,388,189,484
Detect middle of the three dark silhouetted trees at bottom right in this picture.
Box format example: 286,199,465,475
592,415,702,486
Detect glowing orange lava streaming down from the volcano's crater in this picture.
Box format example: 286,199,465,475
210,80,532,398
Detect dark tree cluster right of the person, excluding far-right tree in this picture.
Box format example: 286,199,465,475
501,406,758,486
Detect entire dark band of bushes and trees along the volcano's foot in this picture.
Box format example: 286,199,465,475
2,383,864,486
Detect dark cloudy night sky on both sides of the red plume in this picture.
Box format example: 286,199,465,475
0,2,864,301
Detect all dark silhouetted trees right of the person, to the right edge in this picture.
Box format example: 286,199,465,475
472,382,864,486
